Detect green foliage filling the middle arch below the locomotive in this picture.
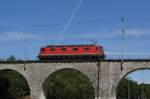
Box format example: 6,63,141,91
47,70,94,99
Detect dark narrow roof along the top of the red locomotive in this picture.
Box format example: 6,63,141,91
46,44,100,47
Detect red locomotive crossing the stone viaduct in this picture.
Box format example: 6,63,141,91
38,44,105,61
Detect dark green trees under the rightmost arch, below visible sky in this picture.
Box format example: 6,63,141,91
117,78,150,99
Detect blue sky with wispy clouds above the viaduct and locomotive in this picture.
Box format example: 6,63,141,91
0,0,150,82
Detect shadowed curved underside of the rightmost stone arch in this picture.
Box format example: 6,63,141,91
115,67,150,99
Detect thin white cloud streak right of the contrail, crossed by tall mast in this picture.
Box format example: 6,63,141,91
80,29,150,39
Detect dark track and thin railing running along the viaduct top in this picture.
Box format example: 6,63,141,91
0,55,150,64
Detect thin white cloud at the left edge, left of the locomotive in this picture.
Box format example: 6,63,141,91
0,32,40,42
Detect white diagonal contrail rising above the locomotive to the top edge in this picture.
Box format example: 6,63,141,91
56,0,85,45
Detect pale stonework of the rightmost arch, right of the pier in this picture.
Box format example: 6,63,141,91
111,60,150,99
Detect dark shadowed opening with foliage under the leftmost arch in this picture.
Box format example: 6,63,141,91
0,69,30,99
